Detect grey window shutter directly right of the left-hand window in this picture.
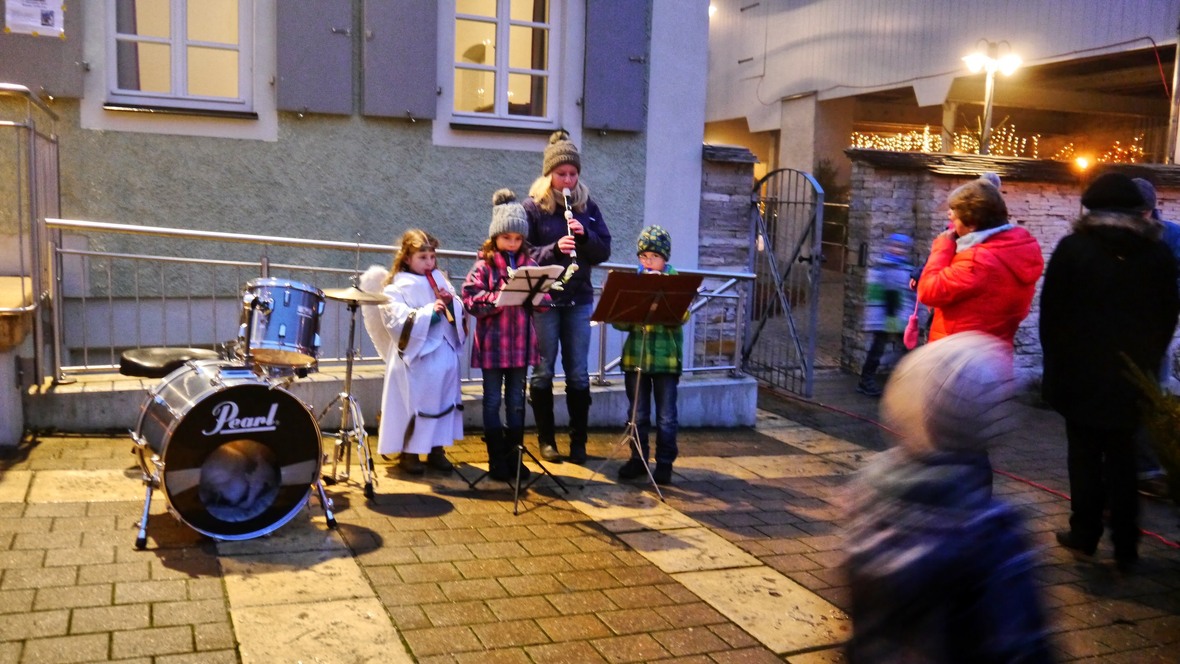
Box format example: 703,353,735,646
275,0,353,116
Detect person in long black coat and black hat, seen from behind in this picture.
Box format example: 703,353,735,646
1041,173,1180,571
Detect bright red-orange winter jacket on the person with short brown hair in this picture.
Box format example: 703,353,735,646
918,226,1044,344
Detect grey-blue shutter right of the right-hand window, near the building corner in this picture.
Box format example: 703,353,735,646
582,0,650,131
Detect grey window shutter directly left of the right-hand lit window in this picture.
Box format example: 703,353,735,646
361,0,439,119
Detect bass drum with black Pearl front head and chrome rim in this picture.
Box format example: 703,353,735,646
135,360,322,540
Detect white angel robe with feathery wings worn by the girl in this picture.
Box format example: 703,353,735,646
360,265,466,454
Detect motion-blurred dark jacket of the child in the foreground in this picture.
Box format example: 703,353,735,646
845,449,1053,664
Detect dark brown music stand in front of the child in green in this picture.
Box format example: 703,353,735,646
582,270,703,501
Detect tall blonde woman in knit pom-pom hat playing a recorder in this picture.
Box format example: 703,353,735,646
524,131,610,464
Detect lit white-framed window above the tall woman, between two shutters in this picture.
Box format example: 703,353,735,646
451,0,561,129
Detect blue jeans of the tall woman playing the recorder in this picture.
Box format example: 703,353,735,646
530,304,592,392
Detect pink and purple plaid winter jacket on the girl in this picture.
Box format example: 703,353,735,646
463,251,549,369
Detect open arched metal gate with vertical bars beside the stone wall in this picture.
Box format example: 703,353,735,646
742,169,824,397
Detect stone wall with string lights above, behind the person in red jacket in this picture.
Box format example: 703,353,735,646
841,150,1180,383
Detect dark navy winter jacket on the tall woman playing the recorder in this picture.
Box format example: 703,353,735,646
523,198,610,307
